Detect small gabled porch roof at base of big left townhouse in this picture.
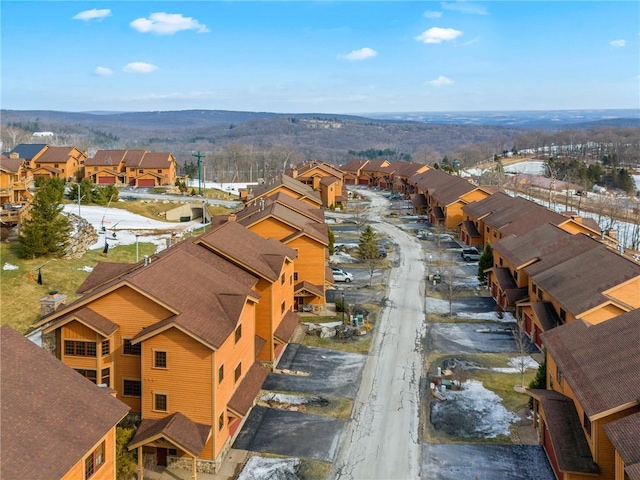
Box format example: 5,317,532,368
129,412,211,457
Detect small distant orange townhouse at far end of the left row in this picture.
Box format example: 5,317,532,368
290,161,347,208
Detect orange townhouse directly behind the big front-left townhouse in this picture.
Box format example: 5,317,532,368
222,192,333,311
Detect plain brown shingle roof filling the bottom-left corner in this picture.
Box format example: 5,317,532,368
0,326,129,479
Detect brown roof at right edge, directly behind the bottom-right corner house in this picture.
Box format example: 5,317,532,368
525,234,640,316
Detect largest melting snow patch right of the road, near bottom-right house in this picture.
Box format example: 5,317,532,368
431,380,519,438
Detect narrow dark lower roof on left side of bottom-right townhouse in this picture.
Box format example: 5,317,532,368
527,389,599,473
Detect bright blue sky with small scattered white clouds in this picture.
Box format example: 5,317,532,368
0,0,640,113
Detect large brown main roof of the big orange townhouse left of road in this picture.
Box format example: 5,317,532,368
39,239,260,348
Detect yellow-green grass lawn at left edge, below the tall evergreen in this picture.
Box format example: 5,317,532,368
0,242,156,333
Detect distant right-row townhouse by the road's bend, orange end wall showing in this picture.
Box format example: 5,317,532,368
409,168,493,229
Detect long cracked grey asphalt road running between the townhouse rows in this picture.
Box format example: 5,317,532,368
332,191,425,480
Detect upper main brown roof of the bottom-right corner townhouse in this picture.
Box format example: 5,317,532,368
542,309,640,420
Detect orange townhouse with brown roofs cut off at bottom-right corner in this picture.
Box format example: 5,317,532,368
528,309,640,480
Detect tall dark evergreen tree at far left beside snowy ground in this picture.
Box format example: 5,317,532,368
18,180,71,258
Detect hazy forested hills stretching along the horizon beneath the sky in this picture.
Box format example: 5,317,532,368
1,110,640,163
